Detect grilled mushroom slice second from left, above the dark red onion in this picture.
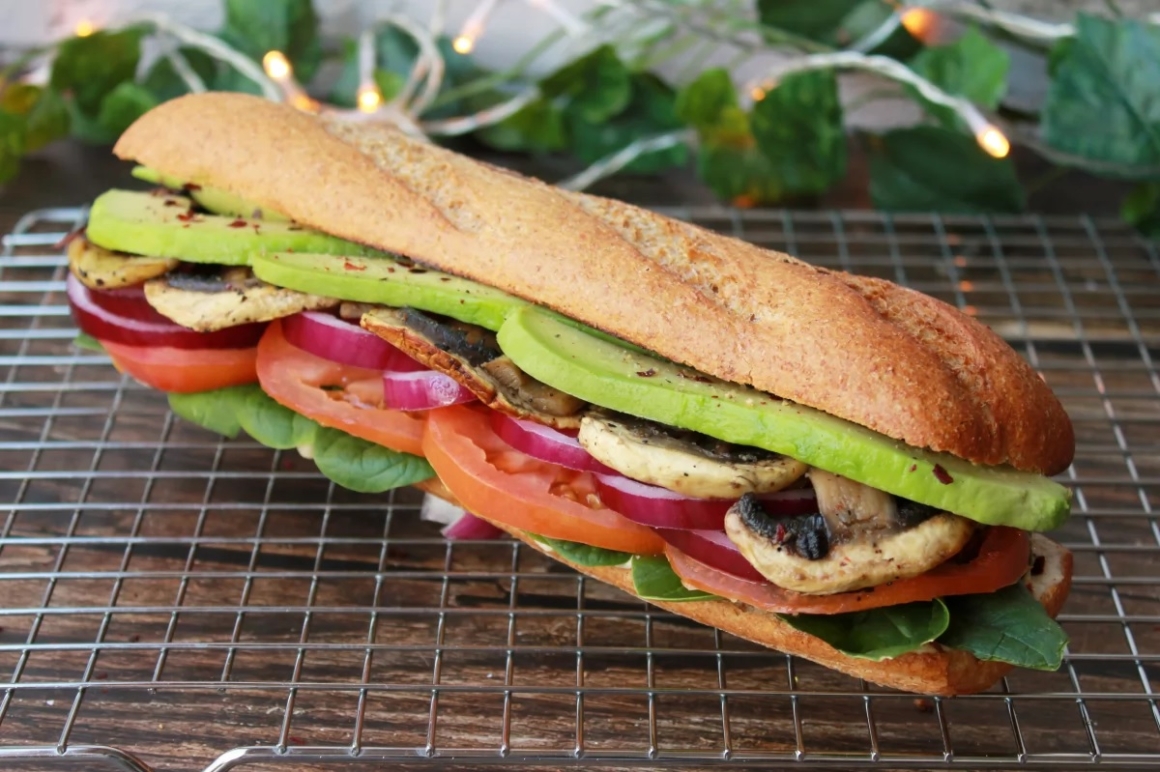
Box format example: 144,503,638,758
145,265,339,333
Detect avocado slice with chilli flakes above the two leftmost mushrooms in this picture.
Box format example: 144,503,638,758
86,190,379,265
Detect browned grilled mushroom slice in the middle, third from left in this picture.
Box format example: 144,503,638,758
362,307,586,429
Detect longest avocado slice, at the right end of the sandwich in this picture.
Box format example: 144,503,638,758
499,306,1071,531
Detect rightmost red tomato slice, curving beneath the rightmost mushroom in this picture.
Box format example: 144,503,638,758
665,525,1031,614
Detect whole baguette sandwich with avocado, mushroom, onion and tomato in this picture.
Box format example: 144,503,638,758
68,93,1074,694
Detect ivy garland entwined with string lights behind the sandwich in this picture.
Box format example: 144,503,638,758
0,0,1160,234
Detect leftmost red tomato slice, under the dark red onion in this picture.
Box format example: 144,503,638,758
100,341,258,393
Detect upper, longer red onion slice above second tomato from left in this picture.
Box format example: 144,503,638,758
282,311,426,372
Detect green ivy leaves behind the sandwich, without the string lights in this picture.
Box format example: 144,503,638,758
0,0,1160,235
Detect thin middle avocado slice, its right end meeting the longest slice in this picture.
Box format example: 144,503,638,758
251,250,528,330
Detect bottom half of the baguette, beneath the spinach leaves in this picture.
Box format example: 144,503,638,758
494,523,1072,697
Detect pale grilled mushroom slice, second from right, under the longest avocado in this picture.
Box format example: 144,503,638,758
578,410,806,498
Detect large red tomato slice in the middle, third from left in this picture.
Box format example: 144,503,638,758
423,407,665,554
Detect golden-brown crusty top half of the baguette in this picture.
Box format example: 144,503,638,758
115,93,1074,474
